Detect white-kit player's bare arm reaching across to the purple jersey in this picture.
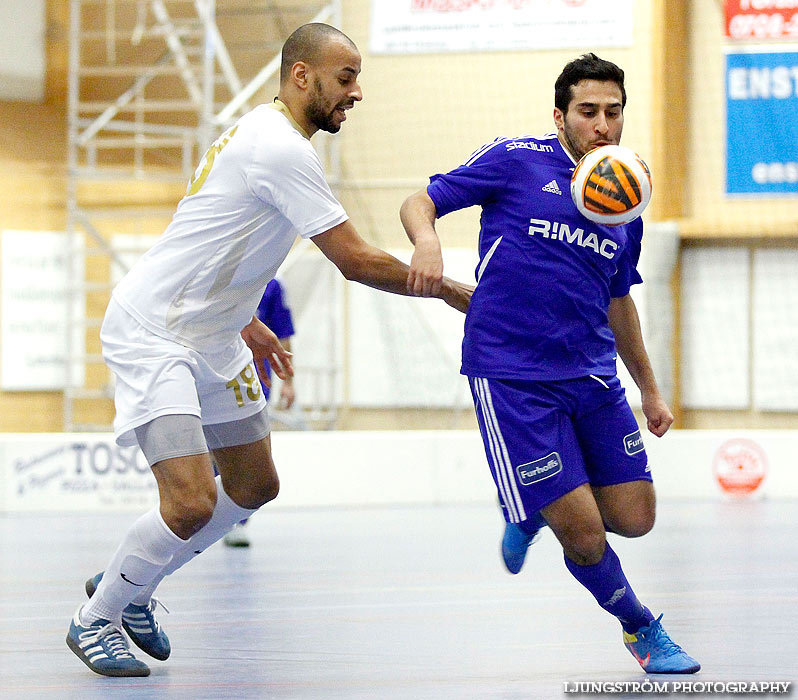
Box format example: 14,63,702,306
311,221,473,313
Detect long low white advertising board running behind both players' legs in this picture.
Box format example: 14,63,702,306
0,430,798,513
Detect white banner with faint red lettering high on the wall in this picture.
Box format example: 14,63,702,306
370,0,634,54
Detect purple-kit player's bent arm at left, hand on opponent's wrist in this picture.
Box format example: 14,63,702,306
399,190,443,297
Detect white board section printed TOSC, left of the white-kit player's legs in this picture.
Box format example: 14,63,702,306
0,435,158,512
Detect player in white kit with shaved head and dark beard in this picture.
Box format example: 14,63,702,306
67,23,472,676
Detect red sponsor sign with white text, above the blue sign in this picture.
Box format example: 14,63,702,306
724,0,798,41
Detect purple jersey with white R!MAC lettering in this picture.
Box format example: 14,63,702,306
427,135,643,380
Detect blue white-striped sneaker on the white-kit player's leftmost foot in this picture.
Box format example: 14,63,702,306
67,608,150,676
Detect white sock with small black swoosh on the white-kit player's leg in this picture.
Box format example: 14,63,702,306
80,508,188,623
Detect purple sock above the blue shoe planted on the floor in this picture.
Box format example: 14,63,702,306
565,542,654,633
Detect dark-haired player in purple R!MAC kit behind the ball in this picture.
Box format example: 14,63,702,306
401,54,700,673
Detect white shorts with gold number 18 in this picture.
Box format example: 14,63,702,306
100,299,266,446
